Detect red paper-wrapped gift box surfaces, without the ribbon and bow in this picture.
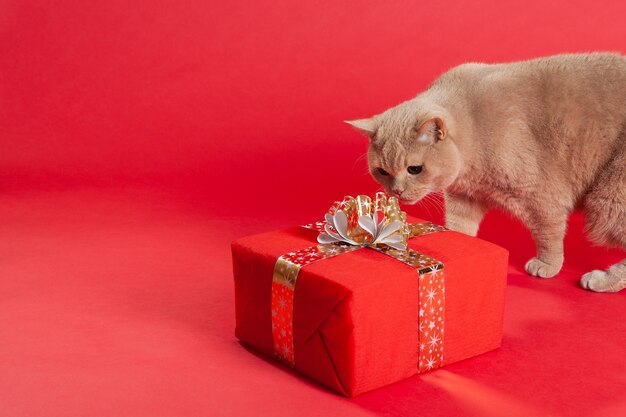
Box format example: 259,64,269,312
232,217,508,397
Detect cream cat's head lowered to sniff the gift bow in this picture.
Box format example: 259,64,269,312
348,105,461,204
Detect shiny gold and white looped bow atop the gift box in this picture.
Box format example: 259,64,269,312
317,192,411,251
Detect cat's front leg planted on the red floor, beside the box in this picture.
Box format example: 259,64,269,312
522,209,568,278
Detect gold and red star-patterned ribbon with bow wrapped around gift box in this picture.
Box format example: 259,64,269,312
271,193,445,372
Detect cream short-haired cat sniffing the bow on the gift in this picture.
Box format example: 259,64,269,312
347,53,626,292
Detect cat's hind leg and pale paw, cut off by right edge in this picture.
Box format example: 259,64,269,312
580,151,626,292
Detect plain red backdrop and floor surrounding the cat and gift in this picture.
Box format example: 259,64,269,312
0,0,626,416
